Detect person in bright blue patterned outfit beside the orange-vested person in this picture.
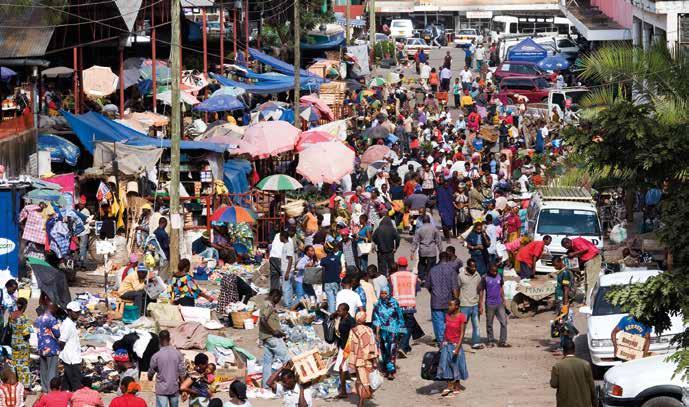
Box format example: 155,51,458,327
373,287,407,380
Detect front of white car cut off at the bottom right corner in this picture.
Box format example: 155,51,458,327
599,355,689,407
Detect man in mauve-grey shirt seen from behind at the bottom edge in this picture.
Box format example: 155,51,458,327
148,329,187,407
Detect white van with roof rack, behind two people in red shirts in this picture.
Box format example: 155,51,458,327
527,187,603,273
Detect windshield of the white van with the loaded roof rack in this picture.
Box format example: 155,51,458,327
537,209,600,236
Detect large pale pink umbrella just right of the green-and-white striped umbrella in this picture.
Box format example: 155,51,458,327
297,141,354,184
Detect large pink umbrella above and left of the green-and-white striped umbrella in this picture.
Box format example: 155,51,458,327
239,120,301,158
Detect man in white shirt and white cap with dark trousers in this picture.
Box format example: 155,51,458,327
59,301,82,392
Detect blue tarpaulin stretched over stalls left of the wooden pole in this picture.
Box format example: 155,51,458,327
61,111,228,154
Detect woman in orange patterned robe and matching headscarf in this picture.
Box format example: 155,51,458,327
349,311,378,407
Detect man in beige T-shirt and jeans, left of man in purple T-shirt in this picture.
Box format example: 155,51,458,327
459,259,483,349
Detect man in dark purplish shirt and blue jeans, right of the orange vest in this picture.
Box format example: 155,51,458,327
426,252,459,345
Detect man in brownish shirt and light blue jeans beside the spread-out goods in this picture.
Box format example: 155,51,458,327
258,289,289,388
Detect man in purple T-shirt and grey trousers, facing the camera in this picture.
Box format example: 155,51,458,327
480,263,511,348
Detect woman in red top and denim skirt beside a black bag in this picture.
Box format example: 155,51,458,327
436,298,469,397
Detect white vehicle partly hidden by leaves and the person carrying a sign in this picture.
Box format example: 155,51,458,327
579,269,684,366
